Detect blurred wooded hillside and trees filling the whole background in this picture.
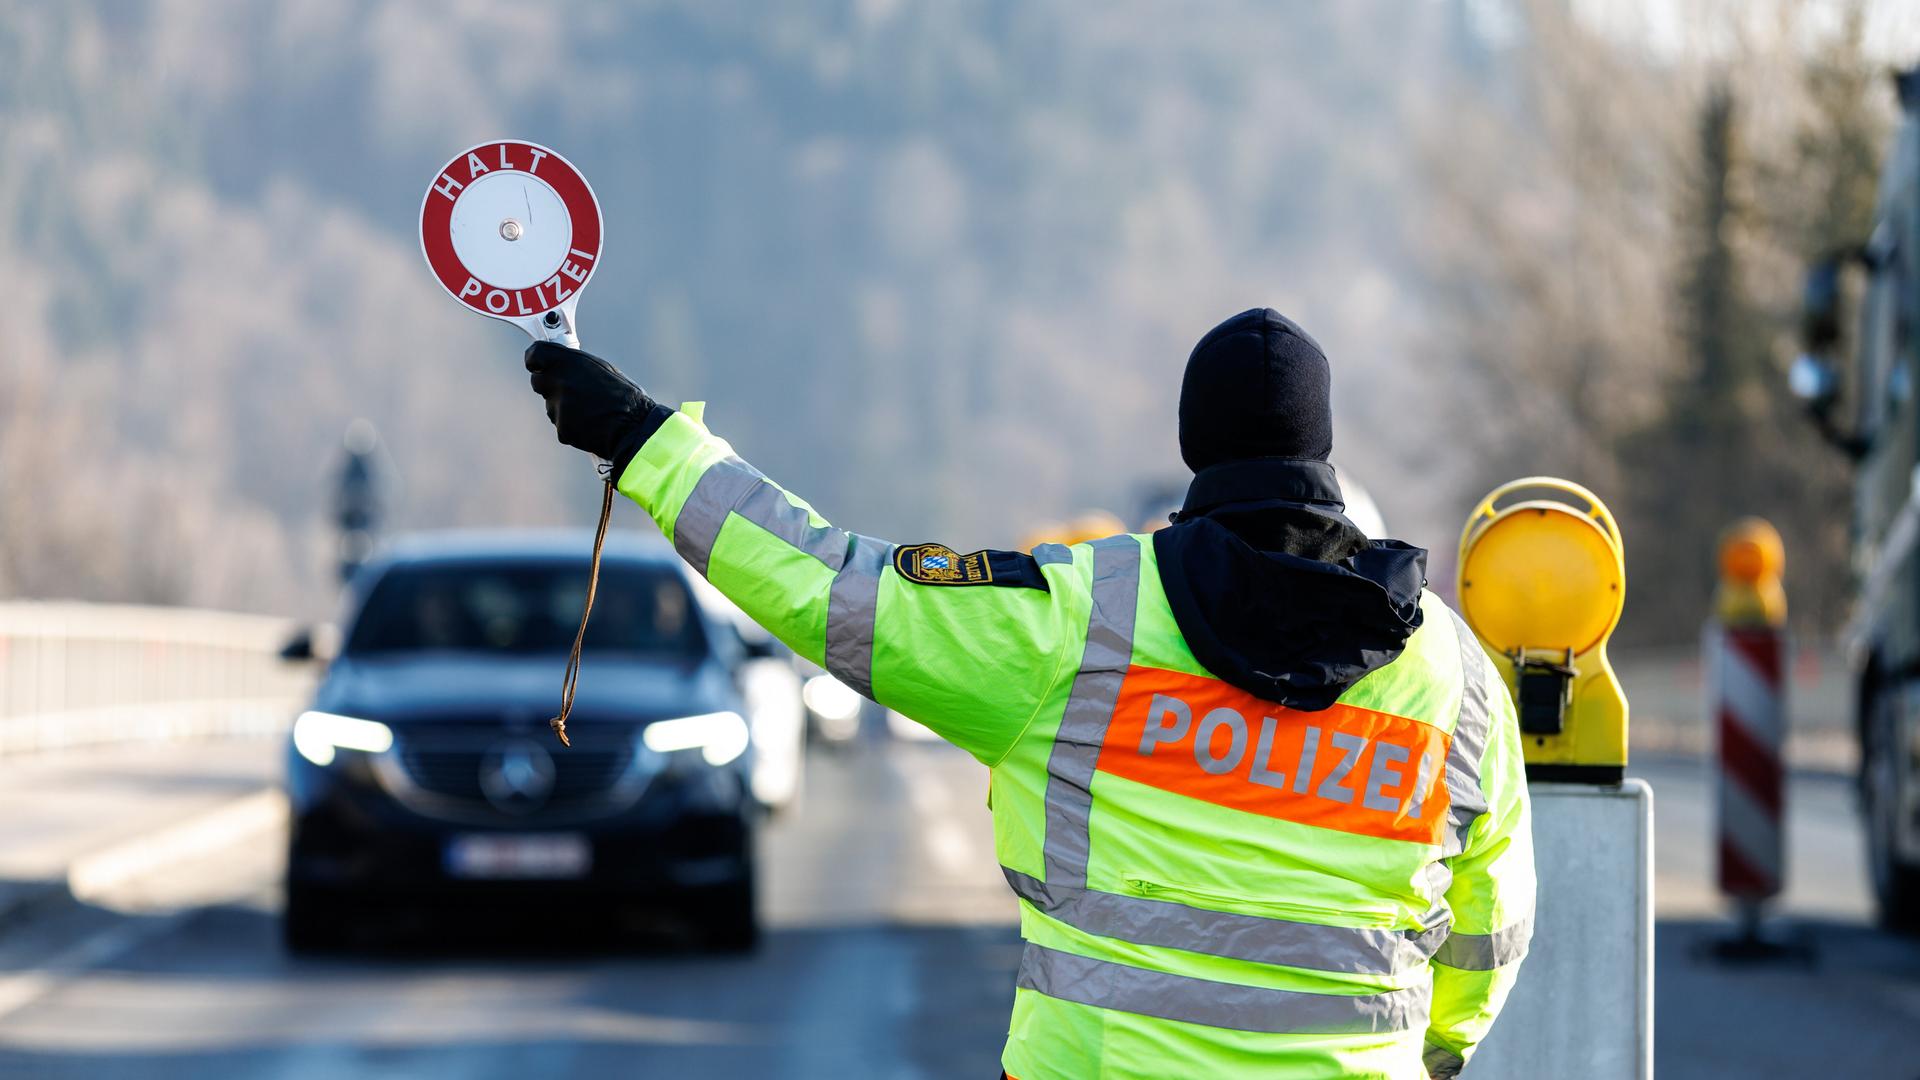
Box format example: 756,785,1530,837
0,0,1920,644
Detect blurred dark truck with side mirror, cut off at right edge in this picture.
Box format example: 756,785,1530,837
1789,69,1920,930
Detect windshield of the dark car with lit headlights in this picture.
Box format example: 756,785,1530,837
346,563,707,657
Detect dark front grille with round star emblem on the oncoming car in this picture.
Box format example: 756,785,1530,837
384,728,649,822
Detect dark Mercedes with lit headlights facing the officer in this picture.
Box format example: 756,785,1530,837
284,532,758,949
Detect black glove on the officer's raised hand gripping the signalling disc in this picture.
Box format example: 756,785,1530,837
526,342,674,468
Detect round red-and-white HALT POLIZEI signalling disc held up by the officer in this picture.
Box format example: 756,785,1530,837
420,138,601,336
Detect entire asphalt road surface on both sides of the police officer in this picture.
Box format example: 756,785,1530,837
0,742,1920,1080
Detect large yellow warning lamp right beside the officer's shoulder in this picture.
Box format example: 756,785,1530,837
1459,477,1626,784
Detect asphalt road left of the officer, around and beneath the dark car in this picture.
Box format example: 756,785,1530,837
0,744,1020,1080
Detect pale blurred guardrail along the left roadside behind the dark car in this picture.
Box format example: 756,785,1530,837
0,601,313,757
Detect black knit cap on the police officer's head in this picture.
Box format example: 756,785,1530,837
1181,307,1332,473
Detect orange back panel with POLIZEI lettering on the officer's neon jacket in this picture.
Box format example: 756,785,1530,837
1100,667,1448,844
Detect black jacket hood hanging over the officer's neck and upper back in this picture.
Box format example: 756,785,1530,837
1154,457,1427,711
